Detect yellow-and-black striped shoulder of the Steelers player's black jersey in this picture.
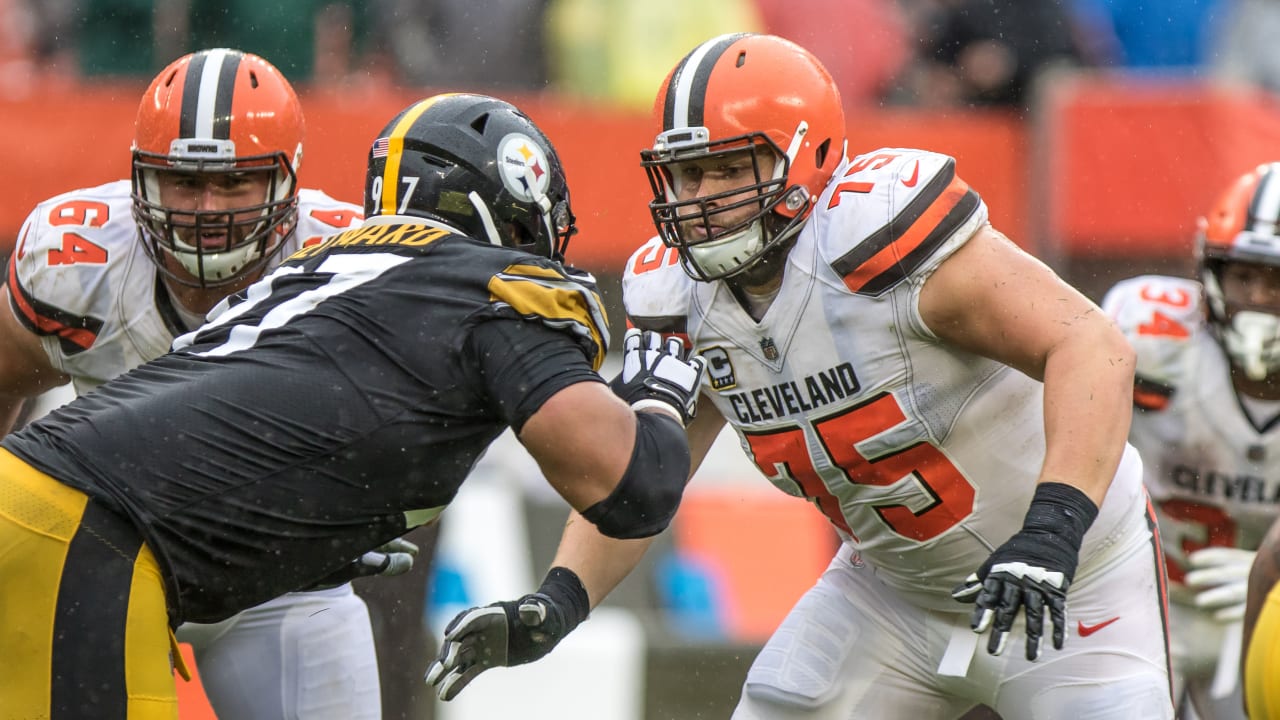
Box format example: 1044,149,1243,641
486,257,609,370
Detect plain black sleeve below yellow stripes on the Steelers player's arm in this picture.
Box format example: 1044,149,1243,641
465,318,604,433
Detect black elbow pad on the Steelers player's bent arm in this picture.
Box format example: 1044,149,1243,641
582,413,690,539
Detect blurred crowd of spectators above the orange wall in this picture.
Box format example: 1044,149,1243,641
0,0,1280,109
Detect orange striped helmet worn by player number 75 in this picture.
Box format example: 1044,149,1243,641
640,33,845,281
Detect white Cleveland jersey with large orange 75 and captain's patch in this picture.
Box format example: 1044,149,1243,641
623,149,1142,611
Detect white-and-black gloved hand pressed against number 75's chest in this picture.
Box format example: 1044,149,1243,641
609,328,707,425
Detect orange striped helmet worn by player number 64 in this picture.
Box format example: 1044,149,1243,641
133,49,303,287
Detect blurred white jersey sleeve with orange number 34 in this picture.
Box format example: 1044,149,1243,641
1102,275,1204,410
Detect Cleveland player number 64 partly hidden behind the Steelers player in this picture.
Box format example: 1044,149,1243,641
0,49,412,720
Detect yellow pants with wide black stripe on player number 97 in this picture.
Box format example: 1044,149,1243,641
0,448,178,720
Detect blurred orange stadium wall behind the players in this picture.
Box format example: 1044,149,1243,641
0,76,1280,273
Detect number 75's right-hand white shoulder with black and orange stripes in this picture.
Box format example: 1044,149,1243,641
813,147,987,296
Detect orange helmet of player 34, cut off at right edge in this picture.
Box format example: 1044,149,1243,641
1196,163,1280,380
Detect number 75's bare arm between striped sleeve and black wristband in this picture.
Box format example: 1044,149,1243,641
920,227,1134,503
